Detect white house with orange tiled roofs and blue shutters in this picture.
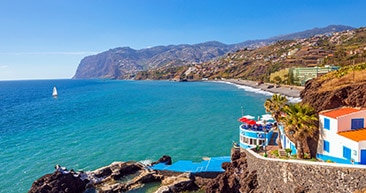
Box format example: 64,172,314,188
317,107,366,165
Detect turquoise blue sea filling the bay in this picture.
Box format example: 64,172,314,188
0,80,269,192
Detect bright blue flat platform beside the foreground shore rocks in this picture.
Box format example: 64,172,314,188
151,156,231,173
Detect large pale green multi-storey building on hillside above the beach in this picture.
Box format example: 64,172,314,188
290,65,339,85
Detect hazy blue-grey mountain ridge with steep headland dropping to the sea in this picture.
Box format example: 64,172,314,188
73,25,353,79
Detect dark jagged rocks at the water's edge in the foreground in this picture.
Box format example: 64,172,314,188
29,151,258,193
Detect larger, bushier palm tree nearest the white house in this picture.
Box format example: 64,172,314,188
283,103,318,159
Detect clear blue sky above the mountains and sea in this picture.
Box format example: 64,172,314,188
0,0,366,80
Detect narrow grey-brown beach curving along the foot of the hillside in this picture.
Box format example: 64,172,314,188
223,79,304,98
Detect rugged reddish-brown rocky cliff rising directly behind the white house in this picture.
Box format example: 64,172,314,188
300,66,366,112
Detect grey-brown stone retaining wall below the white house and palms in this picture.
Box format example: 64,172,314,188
242,149,366,193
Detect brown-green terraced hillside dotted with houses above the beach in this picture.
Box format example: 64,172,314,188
135,28,366,84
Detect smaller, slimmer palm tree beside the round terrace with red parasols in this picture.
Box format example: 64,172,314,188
264,94,288,149
